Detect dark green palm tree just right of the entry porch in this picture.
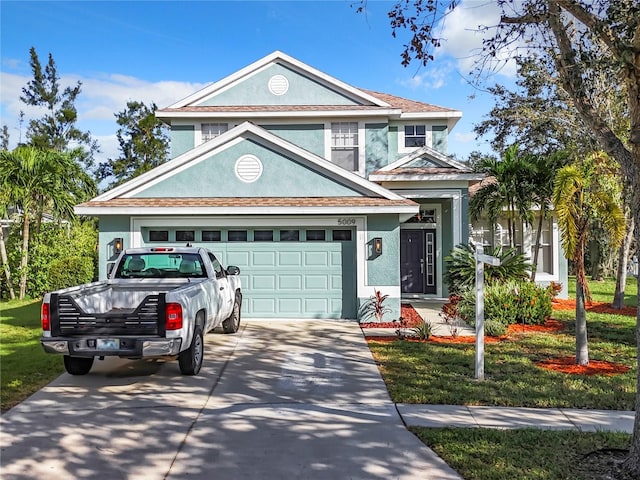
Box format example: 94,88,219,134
469,145,534,247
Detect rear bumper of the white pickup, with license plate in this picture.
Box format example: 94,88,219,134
40,337,182,358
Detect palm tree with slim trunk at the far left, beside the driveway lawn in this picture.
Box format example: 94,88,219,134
0,146,95,299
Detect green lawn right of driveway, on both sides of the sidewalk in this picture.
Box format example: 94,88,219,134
369,278,637,480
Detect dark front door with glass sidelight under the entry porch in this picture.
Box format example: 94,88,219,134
400,230,437,294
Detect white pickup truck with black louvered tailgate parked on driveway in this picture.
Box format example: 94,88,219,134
41,247,242,375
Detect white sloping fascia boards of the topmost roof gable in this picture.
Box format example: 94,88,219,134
167,50,390,108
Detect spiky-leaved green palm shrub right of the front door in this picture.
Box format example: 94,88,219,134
443,243,531,294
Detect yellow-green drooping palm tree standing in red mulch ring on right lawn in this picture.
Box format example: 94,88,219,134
553,152,625,365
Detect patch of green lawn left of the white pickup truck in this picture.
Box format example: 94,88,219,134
0,300,64,412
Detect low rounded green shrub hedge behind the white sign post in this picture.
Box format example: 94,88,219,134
458,281,551,335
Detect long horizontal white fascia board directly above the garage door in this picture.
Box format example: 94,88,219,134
74,204,420,216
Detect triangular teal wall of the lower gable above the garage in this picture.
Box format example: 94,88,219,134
135,140,361,198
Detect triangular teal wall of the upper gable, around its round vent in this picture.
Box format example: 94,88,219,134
198,64,357,106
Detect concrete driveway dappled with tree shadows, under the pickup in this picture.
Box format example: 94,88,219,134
0,320,461,480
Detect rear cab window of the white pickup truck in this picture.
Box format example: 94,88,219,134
114,252,207,278
